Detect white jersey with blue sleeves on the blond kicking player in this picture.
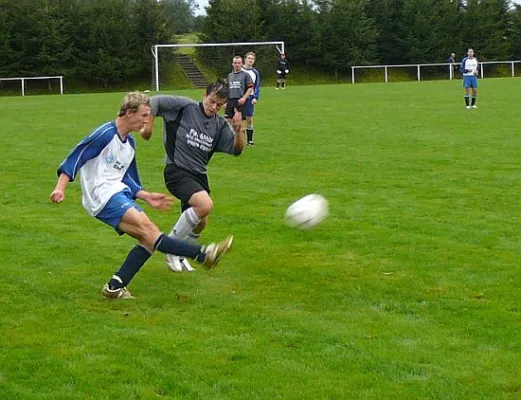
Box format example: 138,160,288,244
58,121,142,216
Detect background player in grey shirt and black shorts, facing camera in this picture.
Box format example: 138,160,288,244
224,56,253,130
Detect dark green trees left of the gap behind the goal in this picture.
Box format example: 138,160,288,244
0,0,195,86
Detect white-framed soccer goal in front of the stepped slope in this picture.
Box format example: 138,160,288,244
152,41,285,91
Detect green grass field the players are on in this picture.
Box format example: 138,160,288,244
0,79,521,400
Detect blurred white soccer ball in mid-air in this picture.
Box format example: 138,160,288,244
285,194,329,229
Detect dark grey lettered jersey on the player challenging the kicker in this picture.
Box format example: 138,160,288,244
150,96,235,175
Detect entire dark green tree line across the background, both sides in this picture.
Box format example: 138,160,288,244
0,0,521,86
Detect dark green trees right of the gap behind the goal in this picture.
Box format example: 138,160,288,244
201,0,521,76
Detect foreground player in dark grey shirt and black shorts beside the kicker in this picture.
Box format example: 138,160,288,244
140,80,246,272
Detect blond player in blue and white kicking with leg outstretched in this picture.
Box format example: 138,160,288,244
51,92,232,299
